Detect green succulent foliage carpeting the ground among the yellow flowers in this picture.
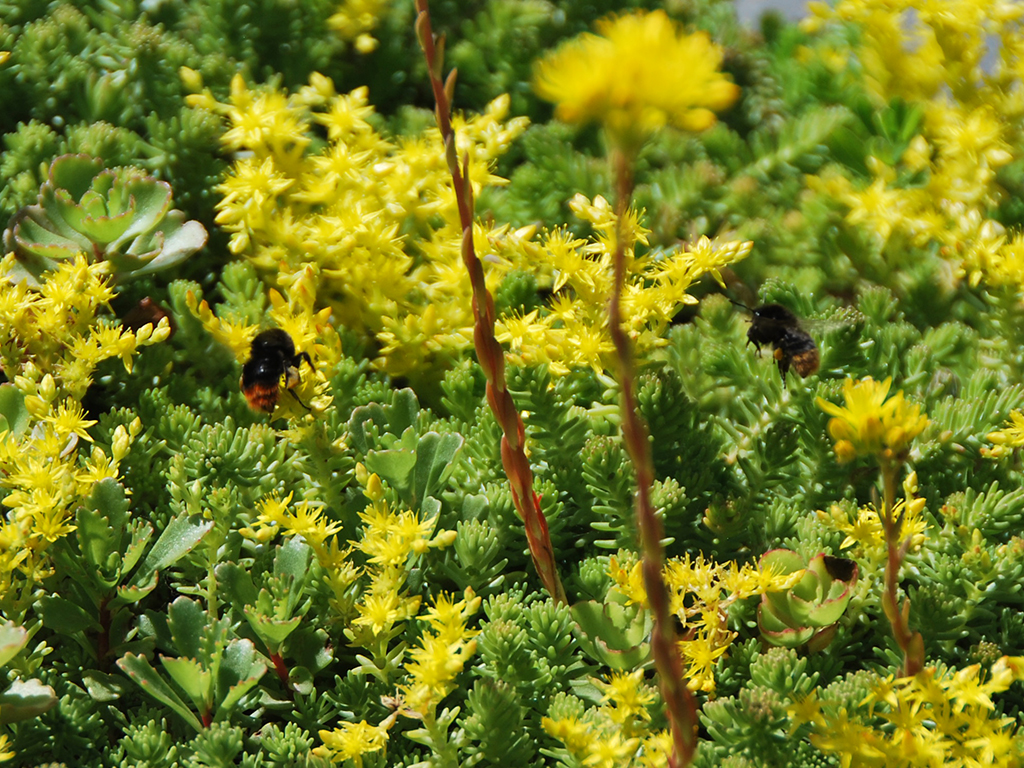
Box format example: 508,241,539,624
6,0,1024,768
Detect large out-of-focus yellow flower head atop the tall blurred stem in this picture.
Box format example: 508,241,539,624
534,10,739,148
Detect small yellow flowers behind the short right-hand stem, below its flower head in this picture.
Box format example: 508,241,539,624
818,472,928,568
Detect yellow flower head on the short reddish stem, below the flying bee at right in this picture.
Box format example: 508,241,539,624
817,377,929,463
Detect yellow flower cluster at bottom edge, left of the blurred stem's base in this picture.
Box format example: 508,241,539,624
541,670,672,768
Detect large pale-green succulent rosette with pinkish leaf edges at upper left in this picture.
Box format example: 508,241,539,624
4,155,207,286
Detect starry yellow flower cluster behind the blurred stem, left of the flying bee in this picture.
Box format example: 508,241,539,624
495,195,754,375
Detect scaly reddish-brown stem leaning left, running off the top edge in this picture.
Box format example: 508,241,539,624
416,0,566,603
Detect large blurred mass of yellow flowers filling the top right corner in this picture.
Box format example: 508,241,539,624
806,0,1024,289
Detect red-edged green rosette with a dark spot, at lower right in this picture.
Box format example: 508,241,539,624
758,549,857,650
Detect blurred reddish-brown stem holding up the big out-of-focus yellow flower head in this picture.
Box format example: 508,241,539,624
608,151,697,768
